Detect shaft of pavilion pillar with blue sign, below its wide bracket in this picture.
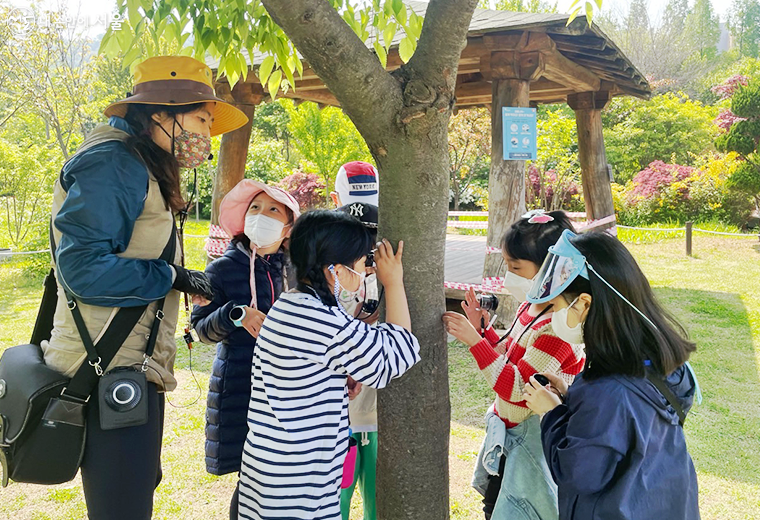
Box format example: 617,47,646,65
483,78,530,276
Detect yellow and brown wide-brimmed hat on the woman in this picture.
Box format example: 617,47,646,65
104,56,248,136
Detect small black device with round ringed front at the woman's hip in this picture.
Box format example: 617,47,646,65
98,369,148,430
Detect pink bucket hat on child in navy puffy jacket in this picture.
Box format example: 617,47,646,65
219,179,301,237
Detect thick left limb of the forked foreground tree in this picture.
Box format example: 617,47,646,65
262,0,400,139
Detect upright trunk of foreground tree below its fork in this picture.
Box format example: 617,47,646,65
376,124,450,520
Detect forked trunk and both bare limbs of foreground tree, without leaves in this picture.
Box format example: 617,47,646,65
263,0,477,520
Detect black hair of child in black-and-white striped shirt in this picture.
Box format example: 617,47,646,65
290,210,372,306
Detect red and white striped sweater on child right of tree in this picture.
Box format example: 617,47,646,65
470,302,586,428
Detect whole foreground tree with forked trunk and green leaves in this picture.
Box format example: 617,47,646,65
103,0,477,520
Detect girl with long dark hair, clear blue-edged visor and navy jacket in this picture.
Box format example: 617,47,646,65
525,231,699,520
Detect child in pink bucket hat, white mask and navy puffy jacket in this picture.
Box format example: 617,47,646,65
192,179,301,519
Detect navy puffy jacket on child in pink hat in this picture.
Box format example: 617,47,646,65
191,242,286,475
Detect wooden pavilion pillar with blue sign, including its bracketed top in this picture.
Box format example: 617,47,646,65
483,45,543,277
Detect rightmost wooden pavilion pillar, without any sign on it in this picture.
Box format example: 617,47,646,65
567,91,615,230
